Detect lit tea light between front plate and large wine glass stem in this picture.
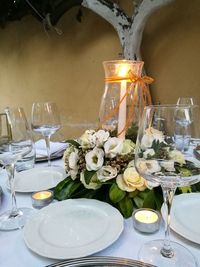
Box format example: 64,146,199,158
132,209,160,233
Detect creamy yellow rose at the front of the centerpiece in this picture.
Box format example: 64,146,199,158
116,167,146,192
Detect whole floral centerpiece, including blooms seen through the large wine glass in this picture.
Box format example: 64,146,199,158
54,127,199,218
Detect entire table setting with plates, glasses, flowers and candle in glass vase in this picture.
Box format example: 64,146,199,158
0,60,200,267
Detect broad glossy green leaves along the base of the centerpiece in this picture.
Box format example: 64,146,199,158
54,177,163,218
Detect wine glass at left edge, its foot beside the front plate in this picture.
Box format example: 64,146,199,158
0,108,33,230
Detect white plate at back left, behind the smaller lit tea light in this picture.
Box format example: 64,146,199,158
7,166,67,193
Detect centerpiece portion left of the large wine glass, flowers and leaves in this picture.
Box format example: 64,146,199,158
54,130,162,218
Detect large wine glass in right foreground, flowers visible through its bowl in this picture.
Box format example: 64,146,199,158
135,105,200,267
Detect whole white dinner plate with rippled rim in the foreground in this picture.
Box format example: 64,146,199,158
23,198,123,259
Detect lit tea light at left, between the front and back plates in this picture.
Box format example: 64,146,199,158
31,190,53,209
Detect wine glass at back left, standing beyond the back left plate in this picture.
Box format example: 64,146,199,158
31,102,60,166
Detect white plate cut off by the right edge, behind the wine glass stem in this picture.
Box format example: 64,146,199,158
170,193,200,244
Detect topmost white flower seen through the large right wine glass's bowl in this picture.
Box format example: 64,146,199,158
141,127,164,150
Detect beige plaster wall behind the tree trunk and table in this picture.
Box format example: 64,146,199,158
0,0,200,138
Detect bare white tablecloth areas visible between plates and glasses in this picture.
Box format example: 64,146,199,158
0,159,200,267
